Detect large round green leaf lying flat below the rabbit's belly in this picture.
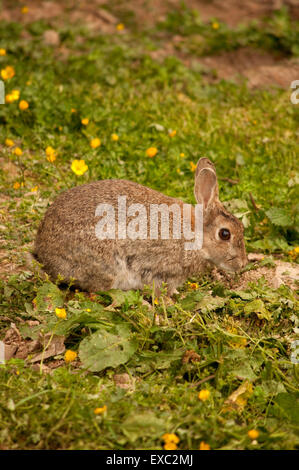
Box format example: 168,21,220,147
79,324,137,372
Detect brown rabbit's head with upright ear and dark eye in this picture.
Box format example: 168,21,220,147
194,158,248,272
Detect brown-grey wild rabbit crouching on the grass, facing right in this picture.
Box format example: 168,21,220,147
34,158,247,295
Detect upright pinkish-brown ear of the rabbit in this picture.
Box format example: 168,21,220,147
194,158,218,209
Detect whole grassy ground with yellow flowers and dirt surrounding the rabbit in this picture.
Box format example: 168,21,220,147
0,0,299,450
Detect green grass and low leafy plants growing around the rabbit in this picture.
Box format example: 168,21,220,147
0,5,299,449
